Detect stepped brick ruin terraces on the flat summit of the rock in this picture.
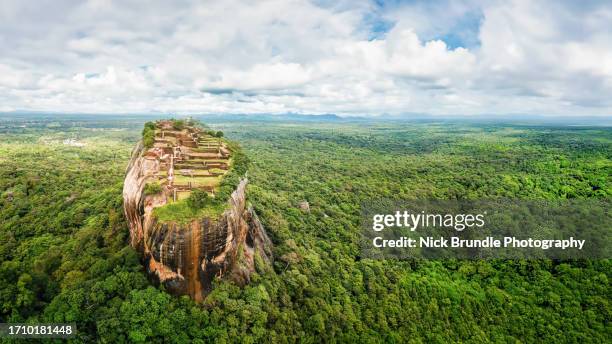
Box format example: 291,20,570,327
144,120,231,203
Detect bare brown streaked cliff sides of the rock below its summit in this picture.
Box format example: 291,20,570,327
123,143,272,301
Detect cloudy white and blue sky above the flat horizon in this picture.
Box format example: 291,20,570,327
0,0,612,116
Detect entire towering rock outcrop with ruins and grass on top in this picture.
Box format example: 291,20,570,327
123,120,272,301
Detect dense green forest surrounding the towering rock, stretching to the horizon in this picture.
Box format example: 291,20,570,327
0,116,612,343
